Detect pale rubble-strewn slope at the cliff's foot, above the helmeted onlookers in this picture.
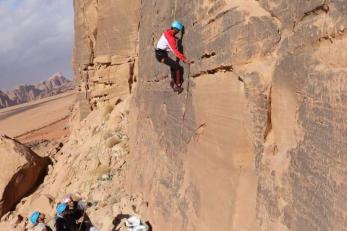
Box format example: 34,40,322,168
0,97,148,231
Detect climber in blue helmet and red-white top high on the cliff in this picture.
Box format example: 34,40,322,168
155,21,192,92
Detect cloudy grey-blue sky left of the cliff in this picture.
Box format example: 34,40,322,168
0,0,74,90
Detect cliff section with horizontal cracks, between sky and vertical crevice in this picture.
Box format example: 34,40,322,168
73,0,139,118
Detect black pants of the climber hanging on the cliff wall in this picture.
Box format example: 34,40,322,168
155,49,183,86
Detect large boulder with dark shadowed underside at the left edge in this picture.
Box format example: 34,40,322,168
0,136,49,217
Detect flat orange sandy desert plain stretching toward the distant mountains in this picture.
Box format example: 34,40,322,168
0,91,76,142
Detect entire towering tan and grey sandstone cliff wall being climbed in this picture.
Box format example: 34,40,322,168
74,0,347,231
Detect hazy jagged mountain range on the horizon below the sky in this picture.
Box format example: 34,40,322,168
0,73,74,108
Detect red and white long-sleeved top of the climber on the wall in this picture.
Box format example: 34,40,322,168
157,29,187,61
